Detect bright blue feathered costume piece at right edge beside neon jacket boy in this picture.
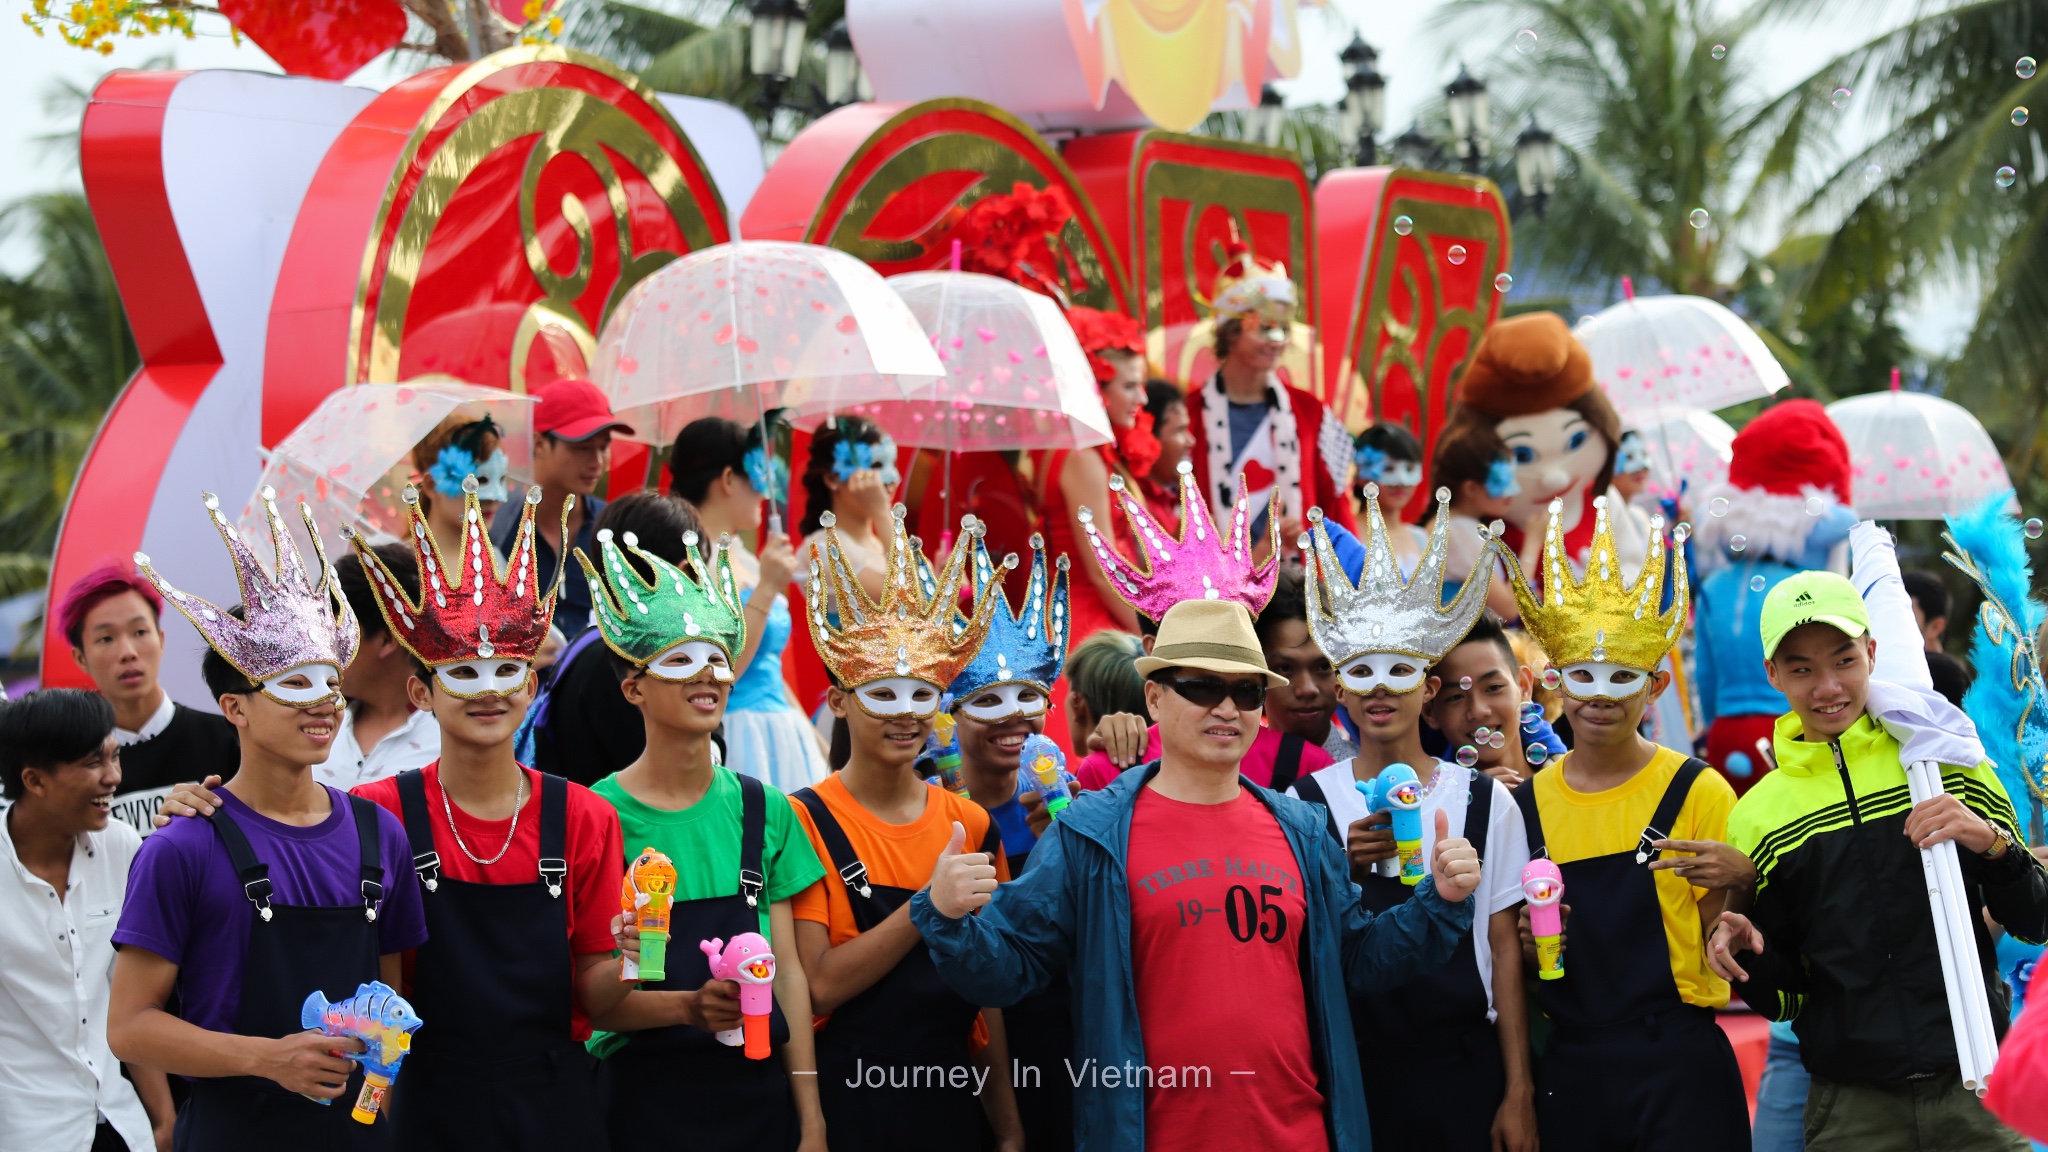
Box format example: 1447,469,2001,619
1944,492,2048,845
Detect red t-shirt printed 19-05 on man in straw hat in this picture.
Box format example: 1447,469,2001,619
1130,787,1329,1152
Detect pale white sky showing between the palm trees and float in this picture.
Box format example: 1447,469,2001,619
0,0,1974,355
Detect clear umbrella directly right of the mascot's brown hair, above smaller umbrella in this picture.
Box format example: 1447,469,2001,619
1573,279,1790,414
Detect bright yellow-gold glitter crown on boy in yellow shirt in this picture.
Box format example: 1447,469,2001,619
1501,496,1692,672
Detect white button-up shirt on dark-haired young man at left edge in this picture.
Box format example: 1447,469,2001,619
0,814,156,1152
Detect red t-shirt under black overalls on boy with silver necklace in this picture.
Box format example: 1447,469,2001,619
352,760,627,1039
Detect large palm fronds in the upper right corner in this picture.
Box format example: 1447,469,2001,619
1757,0,2048,426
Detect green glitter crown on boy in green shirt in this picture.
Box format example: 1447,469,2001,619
575,529,748,666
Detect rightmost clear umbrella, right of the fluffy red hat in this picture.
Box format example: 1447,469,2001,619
1827,369,2013,521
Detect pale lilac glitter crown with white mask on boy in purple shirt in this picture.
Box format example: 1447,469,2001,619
135,488,362,707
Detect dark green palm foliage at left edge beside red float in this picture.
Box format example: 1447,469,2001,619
0,193,141,582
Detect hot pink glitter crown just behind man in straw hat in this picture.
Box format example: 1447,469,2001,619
1081,461,1280,621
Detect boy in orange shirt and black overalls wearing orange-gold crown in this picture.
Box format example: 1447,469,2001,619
791,504,1024,1152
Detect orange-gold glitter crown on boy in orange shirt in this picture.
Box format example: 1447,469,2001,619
805,504,1004,691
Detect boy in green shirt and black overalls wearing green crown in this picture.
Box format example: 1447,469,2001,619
575,531,825,1152
